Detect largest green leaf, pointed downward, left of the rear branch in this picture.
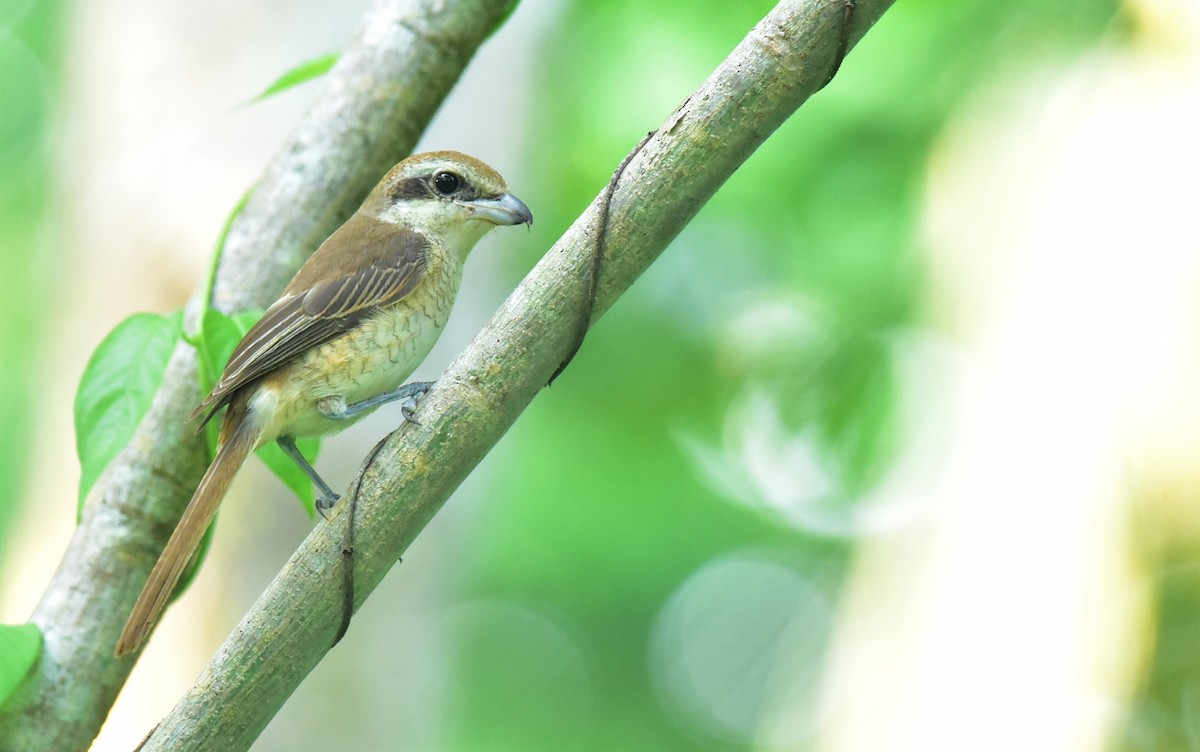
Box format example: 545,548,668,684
74,313,182,512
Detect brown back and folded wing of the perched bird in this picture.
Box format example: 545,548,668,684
192,215,430,425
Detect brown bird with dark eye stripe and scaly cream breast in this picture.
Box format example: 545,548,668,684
114,151,533,656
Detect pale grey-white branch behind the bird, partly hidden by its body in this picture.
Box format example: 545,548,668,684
0,0,516,752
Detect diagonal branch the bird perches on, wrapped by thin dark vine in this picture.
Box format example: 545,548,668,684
144,0,892,751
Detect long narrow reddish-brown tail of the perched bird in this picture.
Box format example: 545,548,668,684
114,404,260,656
